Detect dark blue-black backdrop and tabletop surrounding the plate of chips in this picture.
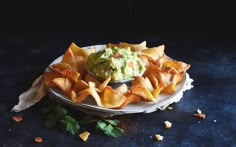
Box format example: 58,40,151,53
0,0,236,147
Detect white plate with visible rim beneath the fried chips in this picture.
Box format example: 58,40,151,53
46,45,193,116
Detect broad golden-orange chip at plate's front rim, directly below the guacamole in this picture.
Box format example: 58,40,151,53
100,86,127,108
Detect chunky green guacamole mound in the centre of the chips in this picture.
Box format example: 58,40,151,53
86,47,145,81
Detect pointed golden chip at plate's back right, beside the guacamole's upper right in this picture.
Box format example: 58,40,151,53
141,45,165,61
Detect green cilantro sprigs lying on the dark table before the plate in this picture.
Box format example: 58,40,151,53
42,101,124,137
